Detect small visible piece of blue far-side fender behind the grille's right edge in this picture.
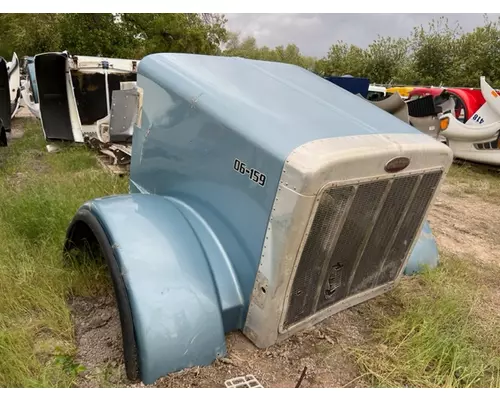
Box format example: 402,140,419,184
404,221,439,275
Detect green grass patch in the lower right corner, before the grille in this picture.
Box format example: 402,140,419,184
352,255,500,387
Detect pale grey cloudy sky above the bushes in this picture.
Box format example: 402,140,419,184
226,14,500,57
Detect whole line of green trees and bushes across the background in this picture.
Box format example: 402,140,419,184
0,13,500,87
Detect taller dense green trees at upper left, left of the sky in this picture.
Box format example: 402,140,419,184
0,13,227,58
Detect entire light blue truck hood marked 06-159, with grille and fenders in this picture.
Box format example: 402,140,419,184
62,54,452,384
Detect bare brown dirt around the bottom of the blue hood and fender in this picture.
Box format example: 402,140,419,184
72,298,376,387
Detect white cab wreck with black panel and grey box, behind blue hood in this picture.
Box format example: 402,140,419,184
35,52,140,170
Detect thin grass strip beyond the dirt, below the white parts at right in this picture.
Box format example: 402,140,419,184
446,163,500,201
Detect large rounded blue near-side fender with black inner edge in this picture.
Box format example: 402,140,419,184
65,194,226,384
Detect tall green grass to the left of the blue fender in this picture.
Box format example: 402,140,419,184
0,122,128,387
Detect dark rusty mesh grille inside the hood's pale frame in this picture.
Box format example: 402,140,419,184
284,171,442,328
